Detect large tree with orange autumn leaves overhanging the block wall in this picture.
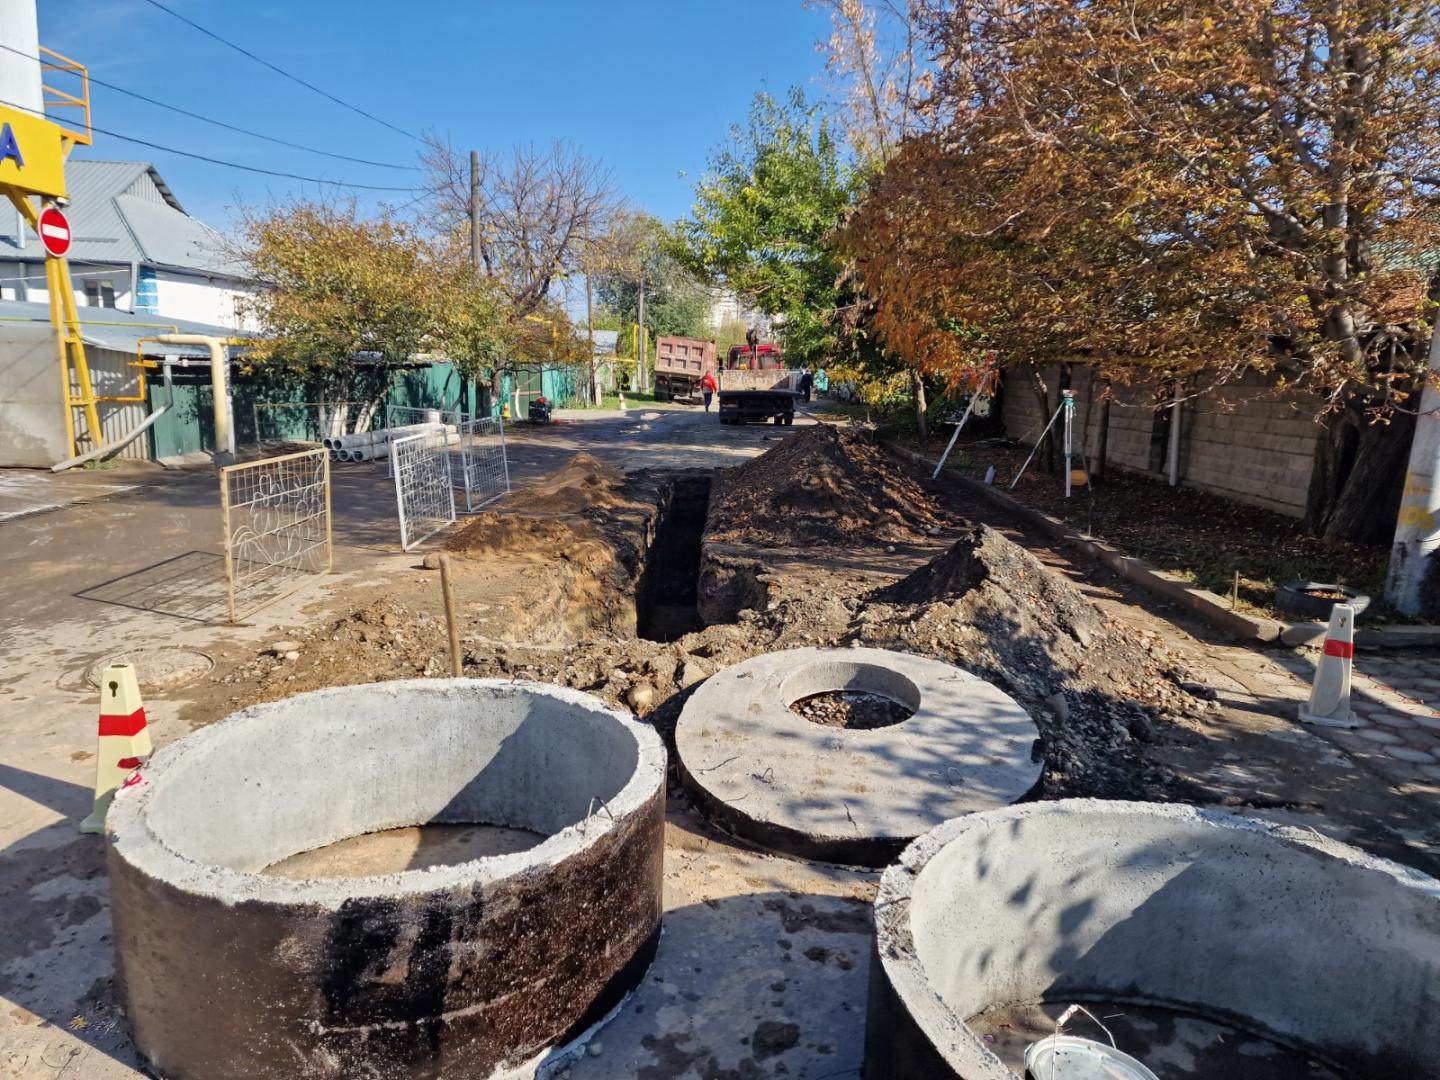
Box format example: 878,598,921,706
844,0,1440,540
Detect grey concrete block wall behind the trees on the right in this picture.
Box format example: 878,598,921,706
1002,364,1322,517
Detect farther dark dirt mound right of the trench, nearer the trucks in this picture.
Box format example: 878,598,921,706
707,423,946,547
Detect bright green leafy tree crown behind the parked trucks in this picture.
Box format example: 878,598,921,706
672,88,855,363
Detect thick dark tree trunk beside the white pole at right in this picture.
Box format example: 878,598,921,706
1302,399,1416,544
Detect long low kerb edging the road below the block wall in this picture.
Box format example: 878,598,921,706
884,441,1440,648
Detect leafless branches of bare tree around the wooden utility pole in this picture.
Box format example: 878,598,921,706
420,134,622,317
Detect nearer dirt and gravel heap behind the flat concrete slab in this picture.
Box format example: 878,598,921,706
861,526,1205,798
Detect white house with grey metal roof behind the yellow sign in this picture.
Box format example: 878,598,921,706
0,160,251,330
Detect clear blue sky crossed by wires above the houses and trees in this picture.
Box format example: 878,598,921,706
39,0,828,229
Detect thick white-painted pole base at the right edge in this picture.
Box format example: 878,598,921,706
1385,321,1440,615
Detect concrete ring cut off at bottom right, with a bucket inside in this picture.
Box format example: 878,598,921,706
865,799,1440,1080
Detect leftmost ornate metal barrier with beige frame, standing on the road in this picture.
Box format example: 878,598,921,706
220,449,331,622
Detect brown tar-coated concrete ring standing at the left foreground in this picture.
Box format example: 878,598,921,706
108,678,665,1080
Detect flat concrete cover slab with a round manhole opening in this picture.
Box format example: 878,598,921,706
675,648,1041,867
